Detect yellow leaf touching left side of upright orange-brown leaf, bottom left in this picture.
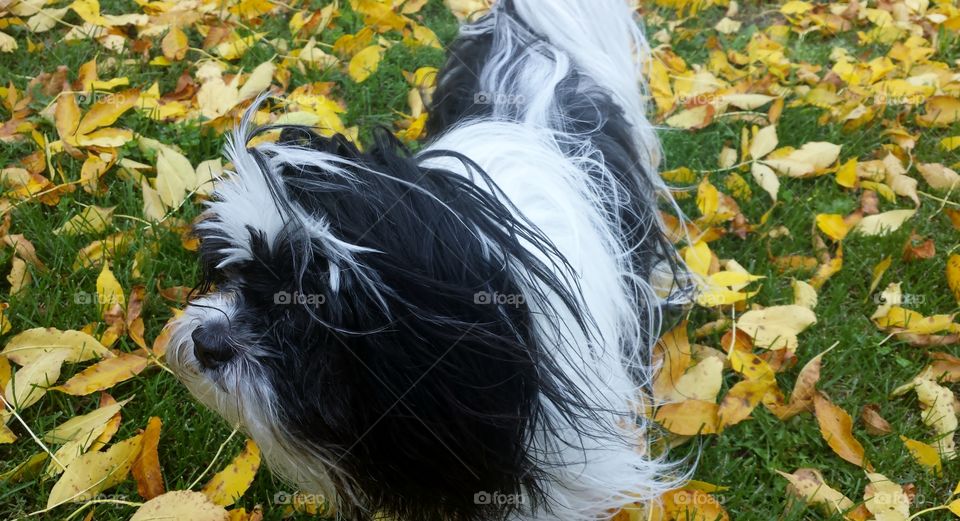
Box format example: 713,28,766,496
47,434,143,508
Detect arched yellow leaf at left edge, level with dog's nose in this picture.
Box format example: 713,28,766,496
0,327,114,365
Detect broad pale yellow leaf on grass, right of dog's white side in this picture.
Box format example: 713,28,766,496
737,305,817,351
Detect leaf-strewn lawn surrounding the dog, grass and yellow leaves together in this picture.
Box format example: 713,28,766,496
0,0,960,521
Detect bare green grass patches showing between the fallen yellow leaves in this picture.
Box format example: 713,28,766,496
0,0,960,521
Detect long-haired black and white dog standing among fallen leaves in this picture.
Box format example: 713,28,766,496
167,0,689,521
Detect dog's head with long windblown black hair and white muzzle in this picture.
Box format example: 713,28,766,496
167,107,596,519
